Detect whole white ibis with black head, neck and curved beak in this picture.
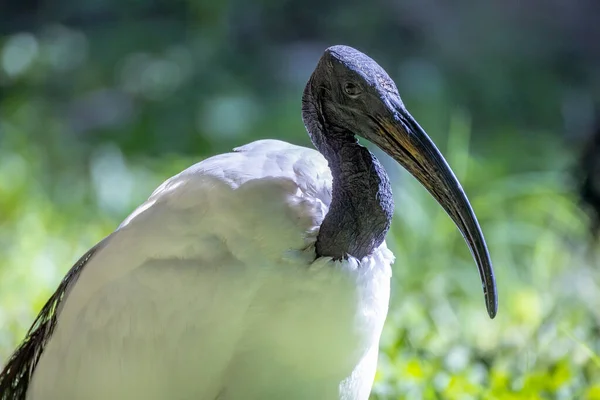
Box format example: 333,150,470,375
0,45,498,400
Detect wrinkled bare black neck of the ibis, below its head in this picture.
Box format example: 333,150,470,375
303,93,394,259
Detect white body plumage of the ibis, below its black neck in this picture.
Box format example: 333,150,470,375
27,140,393,400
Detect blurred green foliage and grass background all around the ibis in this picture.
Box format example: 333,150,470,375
0,0,600,400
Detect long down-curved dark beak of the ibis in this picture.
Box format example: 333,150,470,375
370,99,498,318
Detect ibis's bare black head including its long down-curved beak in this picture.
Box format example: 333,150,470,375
303,46,498,318
